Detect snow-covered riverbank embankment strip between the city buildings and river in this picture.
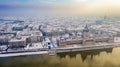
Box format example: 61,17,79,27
0,44,120,57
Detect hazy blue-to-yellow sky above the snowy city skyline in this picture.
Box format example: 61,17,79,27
0,0,120,15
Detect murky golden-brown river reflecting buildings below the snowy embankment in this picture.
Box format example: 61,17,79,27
0,48,120,67
